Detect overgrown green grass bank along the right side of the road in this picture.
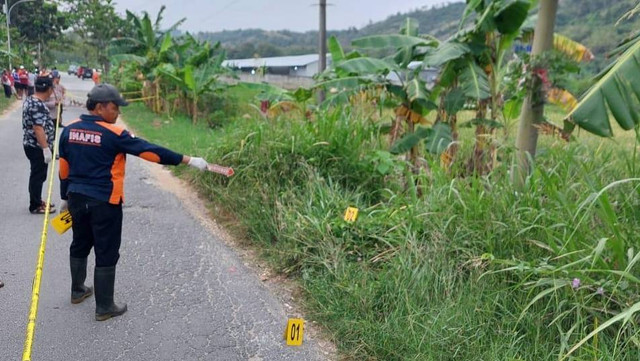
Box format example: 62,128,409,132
124,88,640,361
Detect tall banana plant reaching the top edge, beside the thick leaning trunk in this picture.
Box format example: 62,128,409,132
424,0,531,174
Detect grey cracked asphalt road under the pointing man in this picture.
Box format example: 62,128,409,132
0,75,326,361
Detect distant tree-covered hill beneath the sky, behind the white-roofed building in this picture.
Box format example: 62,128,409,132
196,0,640,70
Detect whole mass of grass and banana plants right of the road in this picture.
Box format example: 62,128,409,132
101,0,640,361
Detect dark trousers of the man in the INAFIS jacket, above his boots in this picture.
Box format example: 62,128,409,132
69,193,122,267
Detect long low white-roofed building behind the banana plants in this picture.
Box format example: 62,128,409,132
222,54,331,78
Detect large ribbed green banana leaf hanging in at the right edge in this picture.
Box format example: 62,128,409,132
565,40,640,137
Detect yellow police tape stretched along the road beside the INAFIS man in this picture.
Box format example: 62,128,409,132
22,104,62,361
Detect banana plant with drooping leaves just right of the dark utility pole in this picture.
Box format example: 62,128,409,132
317,19,447,171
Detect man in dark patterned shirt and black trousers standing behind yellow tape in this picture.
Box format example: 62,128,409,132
22,77,56,214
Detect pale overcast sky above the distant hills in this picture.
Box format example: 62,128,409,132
115,0,455,32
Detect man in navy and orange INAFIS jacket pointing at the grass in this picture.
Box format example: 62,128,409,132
59,83,208,321
